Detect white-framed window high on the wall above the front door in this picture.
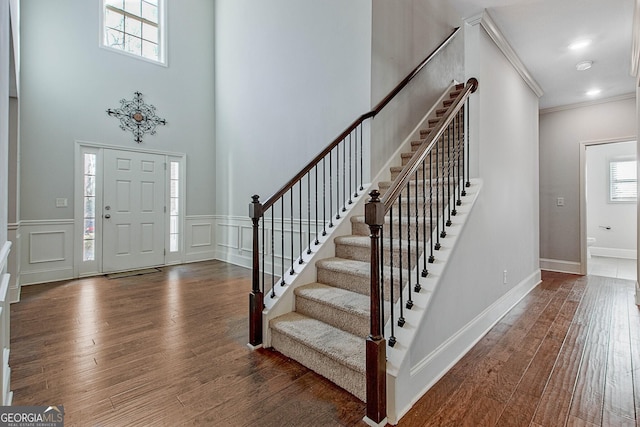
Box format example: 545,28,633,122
101,0,165,64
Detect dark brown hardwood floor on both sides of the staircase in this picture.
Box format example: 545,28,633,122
10,261,640,427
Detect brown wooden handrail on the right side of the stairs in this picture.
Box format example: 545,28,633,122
380,78,478,213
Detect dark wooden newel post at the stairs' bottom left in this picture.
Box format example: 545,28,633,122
249,195,264,347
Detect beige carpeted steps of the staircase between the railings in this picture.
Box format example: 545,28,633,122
269,85,464,401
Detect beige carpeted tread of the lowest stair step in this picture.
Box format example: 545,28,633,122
270,311,365,374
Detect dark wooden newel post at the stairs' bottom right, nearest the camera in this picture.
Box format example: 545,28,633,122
364,190,387,424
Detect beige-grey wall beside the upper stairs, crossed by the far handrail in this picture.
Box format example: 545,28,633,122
371,0,464,176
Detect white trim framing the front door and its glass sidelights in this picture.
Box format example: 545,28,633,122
73,140,186,277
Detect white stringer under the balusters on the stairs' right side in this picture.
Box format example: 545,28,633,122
384,179,482,425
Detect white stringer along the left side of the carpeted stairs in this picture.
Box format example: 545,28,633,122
262,80,459,347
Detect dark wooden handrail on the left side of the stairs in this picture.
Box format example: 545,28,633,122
262,27,460,210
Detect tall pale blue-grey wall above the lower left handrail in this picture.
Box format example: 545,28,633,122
215,0,371,218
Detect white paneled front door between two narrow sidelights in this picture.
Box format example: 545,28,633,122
102,149,165,273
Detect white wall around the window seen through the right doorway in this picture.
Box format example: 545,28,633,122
586,141,637,258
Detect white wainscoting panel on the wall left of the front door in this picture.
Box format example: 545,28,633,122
19,220,74,285
